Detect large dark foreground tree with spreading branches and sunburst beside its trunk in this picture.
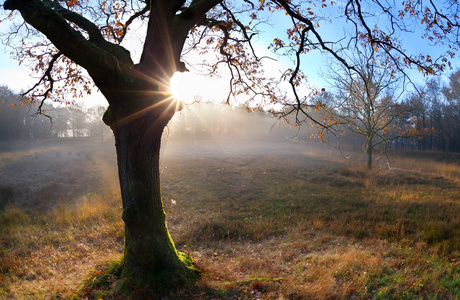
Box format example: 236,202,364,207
3,0,460,294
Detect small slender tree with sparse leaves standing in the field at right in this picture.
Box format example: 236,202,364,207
328,55,402,170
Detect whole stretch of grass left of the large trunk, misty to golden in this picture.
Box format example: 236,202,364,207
0,138,123,299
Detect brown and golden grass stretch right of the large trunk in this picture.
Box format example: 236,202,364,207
163,144,460,299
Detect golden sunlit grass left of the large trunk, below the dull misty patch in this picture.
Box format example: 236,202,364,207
0,139,123,299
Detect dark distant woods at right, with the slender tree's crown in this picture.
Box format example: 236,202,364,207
313,68,460,152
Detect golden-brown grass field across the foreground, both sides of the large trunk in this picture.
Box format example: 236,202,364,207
0,140,460,299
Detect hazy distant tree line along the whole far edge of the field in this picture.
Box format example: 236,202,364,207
0,69,460,152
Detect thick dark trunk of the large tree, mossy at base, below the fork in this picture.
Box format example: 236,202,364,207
106,92,197,291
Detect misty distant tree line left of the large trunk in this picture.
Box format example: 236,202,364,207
0,86,111,141
